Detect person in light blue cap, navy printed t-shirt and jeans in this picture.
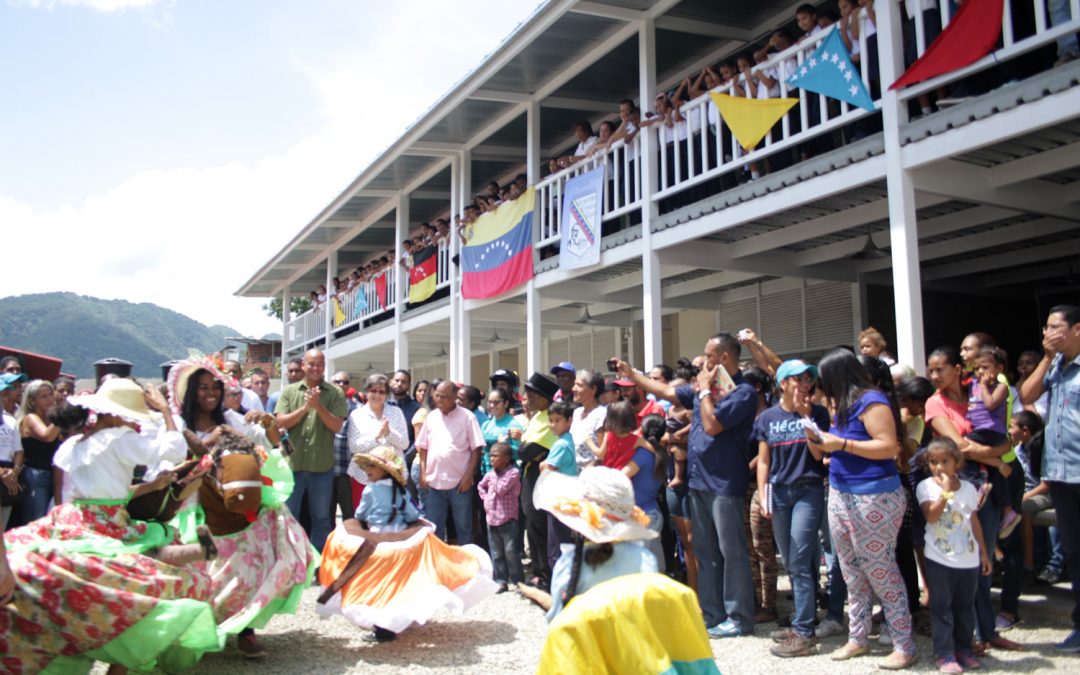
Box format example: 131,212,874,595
753,360,828,657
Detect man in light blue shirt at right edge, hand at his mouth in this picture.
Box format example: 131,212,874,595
1021,305,1080,652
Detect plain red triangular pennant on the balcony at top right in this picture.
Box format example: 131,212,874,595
889,0,1004,90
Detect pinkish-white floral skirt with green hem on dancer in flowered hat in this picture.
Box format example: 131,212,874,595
198,505,319,636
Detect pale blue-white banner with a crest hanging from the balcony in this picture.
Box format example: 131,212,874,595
558,165,604,270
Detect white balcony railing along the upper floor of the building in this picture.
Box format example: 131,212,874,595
285,0,1080,350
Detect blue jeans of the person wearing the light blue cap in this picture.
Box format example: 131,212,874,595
772,478,825,637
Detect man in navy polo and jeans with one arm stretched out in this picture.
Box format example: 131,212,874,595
618,333,757,638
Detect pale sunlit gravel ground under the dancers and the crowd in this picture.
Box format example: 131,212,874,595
95,577,1080,675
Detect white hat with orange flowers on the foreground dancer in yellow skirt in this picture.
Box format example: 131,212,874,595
532,467,659,543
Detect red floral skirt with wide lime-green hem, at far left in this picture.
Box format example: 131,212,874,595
0,502,222,673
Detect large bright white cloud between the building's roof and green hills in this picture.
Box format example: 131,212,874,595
0,0,535,336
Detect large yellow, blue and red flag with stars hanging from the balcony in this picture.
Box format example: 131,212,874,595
461,188,536,298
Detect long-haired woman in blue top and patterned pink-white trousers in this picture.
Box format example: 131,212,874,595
807,349,916,670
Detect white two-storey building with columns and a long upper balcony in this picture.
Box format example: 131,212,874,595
238,0,1080,382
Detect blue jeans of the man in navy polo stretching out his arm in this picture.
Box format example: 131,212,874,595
690,489,754,634
